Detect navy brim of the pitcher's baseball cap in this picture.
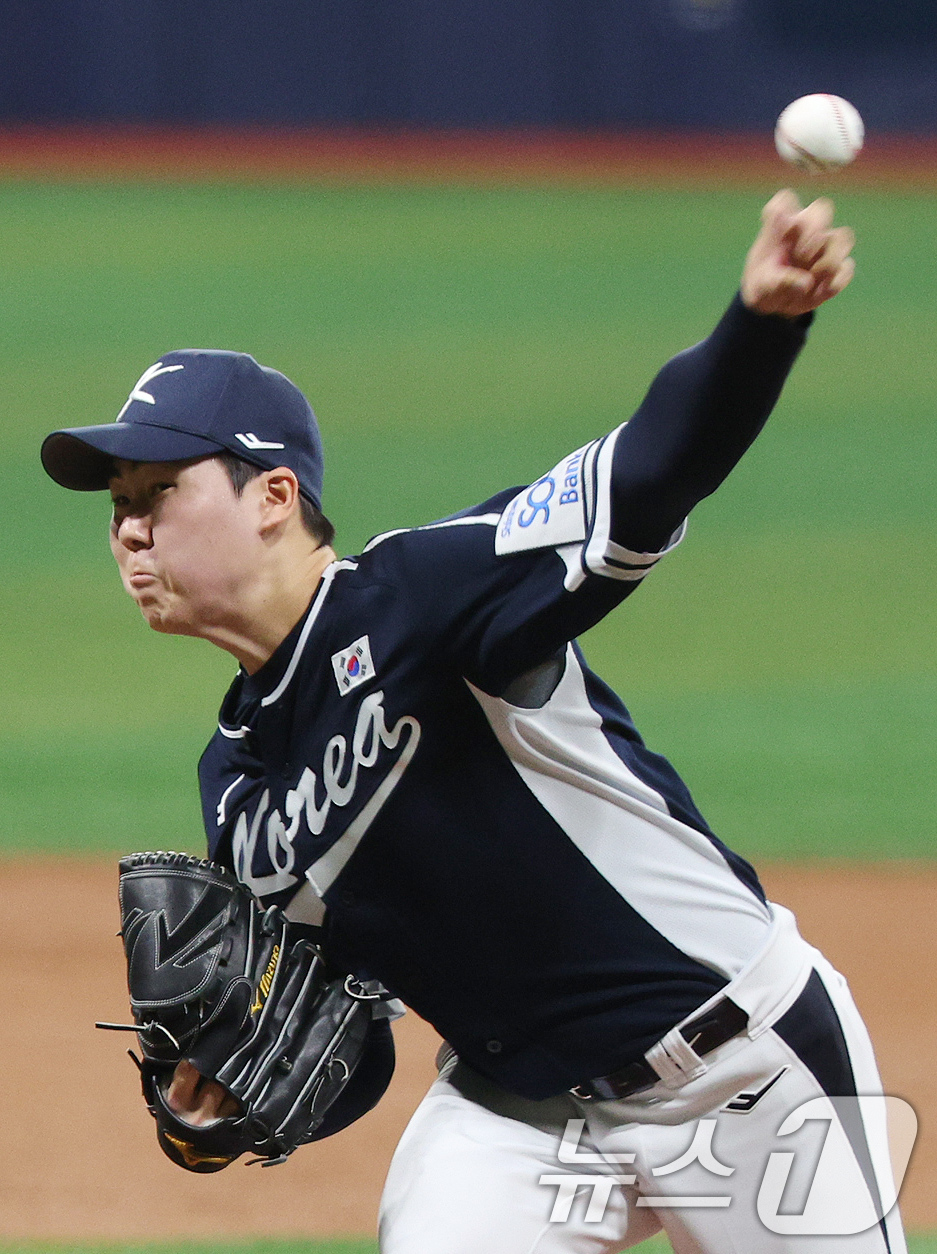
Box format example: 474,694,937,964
40,423,225,492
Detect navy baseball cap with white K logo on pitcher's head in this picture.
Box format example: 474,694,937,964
41,349,322,507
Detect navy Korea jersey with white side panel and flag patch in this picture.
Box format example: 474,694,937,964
199,293,803,1097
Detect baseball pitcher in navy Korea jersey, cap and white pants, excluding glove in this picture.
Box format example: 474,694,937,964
43,192,904,1254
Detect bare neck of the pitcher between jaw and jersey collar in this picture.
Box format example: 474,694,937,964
197,544,335,675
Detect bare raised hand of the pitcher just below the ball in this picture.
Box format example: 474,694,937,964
741,191,855,317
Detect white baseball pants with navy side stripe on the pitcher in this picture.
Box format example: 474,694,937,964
380,907,906,1254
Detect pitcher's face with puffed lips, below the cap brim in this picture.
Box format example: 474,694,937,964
109,458,261,636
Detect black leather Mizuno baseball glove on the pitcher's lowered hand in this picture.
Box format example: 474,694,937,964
100,853,393,1171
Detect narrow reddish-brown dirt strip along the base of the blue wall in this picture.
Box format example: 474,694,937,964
0,127,937,191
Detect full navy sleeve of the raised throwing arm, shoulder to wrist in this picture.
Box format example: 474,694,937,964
376,298,807,696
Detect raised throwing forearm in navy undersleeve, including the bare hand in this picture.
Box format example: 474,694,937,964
610,191,854,553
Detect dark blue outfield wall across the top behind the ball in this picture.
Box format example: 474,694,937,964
0,0,937,133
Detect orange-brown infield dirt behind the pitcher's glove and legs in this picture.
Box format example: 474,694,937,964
0,860,937,1240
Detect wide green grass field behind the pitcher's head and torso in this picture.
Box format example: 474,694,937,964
0,182,937,858
